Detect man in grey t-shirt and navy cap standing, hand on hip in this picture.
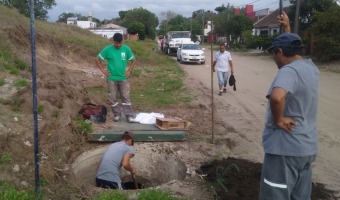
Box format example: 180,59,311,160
260,14,319,200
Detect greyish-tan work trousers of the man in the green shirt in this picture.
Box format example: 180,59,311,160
106,80,133,117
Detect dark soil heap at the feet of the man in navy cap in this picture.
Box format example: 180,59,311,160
197,157,336,200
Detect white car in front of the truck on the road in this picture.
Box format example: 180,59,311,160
177,43,205,64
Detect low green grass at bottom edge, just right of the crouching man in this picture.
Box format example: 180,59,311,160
138,189,184,200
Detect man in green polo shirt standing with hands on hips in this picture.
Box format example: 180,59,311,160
96,33,136,123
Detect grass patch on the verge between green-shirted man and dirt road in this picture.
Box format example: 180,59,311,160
131,59,193,106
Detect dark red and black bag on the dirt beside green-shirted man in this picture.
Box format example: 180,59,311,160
79,103,107,123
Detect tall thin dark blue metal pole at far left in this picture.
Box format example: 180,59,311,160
30,0,40,195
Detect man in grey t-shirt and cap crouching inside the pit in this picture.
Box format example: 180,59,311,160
96,131,136,190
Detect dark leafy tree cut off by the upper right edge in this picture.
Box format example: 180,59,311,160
308,6,340,60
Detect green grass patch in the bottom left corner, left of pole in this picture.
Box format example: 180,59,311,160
0,181,35,200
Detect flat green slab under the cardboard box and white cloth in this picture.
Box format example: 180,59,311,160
87,120,186,142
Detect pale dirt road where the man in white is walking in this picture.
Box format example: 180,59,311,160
178,49,340,190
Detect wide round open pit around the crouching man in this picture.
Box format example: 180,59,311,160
72,143,187,189
